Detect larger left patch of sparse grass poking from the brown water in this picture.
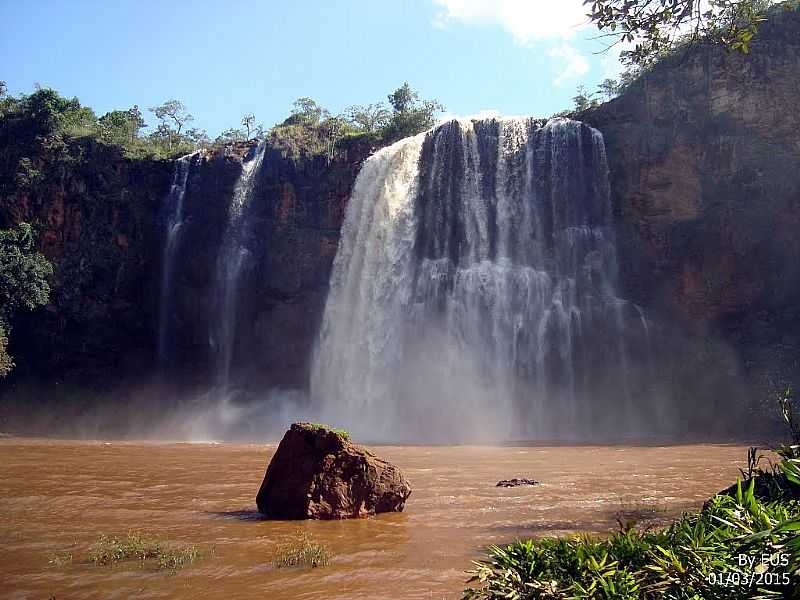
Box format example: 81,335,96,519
88,532,213,571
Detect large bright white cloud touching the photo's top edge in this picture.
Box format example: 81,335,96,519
433,0,589,46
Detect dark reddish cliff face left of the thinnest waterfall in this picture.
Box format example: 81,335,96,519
0,138,172,383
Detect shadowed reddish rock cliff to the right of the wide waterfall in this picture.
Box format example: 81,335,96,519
581,5,800,418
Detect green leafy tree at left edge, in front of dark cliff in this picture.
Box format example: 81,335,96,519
0,223,53,377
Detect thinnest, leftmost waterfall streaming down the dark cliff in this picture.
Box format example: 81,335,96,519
158,154,196,369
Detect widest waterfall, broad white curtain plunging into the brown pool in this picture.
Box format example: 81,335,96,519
311,119,645,440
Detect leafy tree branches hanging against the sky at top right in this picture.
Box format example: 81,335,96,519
584,0,773,65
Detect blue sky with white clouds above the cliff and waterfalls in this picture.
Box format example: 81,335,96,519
0,0,618,137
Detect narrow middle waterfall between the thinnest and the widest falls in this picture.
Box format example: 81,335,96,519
209,142,266,389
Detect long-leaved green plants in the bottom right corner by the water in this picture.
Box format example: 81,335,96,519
464,472,800,600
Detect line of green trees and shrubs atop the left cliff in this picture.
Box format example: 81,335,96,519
0,81,444,164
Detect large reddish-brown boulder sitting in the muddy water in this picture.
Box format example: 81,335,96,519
256,423,411,519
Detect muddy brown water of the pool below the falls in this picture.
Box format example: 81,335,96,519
0,438,746,600
